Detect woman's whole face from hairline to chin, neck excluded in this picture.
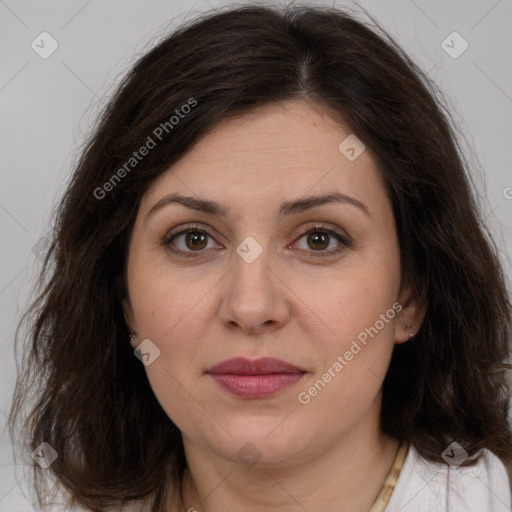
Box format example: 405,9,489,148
123,101,419,464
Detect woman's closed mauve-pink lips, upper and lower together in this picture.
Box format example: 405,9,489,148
206,357,306,398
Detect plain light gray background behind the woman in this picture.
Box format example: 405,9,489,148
0,0,512,512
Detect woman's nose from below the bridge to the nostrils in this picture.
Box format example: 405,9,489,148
219,242,291,334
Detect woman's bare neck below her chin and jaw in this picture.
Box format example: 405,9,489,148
174,416,399,512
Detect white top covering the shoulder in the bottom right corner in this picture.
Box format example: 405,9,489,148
385,445,512,512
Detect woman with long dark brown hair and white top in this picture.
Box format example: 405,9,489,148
11,6,512,512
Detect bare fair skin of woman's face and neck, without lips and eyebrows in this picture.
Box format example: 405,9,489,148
123,101,425,512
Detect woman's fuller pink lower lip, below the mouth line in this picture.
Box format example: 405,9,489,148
209,373,304,398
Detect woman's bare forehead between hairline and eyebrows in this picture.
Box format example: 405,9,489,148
141,101,384,218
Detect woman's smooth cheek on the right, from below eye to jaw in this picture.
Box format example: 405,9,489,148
302,253,401,404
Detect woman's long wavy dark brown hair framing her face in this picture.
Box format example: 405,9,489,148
10,5,512,512
